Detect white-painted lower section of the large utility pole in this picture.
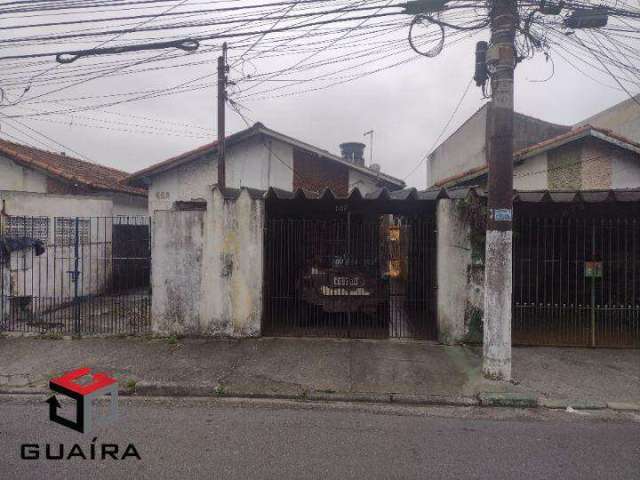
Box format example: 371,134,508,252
482,230,513,381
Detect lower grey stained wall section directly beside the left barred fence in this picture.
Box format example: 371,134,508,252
151,210,205,335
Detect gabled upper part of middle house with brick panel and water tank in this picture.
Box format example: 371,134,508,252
128,123,405,214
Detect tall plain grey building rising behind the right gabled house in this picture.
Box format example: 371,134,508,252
427,103,571,187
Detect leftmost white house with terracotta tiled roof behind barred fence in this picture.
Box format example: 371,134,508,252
0,140,150,327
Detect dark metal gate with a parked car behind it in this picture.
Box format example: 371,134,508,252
263,214,437,339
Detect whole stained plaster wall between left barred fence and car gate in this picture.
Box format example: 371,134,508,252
152,189,264,337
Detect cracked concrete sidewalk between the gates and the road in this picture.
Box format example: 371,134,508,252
0,337,640,406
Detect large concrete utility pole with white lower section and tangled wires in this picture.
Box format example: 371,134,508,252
482,0,518,380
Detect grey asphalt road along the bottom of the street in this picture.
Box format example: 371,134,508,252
0,397,640,480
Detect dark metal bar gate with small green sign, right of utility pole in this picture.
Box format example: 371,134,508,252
513,208,640,347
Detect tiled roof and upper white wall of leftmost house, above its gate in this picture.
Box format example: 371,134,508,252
0,140,147,217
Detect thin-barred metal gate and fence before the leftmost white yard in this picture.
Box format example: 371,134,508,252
0,216,151,335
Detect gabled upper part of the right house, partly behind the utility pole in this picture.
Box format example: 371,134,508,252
437,125,640,191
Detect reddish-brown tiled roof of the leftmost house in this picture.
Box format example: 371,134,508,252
0,140,147,196
